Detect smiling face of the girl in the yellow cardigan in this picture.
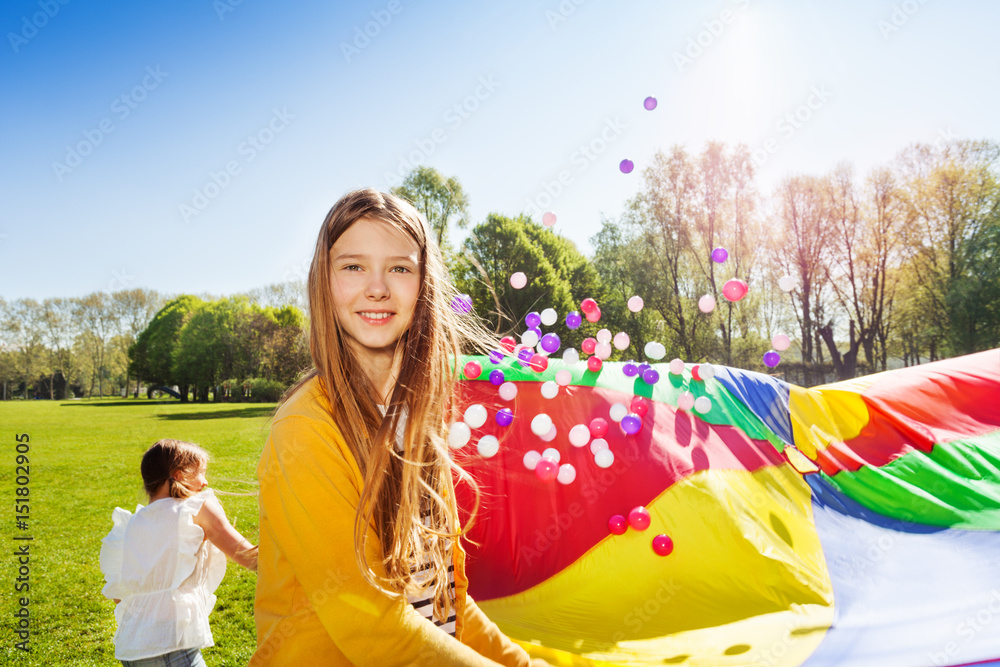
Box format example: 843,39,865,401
330,218,421,354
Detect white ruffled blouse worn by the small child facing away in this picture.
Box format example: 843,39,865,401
101,489,226,660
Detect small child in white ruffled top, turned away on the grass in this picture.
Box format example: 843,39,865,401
101,440,257,667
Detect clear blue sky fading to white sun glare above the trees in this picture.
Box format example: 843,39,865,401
0,0,1000,300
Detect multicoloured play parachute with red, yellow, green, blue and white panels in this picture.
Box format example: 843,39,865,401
460,350,1000,667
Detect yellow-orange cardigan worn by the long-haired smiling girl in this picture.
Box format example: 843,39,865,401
250,378,530,667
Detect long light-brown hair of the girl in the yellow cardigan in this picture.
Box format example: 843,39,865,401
286,188,495,620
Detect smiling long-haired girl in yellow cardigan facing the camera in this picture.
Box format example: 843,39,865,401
251,189,544,666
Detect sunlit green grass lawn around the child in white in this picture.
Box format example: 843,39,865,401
0,399,274,666
